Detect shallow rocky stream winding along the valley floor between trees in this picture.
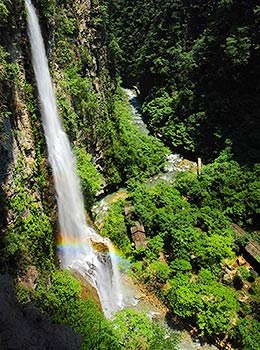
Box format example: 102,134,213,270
93,89,217,350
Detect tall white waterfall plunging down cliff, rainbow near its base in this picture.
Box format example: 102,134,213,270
25,0,122,317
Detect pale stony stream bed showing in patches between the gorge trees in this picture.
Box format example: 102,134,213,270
93,91,217,350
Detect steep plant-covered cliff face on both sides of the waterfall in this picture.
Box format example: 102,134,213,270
0,0,112,276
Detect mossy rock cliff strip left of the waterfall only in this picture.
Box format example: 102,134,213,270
0,2,54,274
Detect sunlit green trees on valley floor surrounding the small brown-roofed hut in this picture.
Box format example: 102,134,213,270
95,174,258,342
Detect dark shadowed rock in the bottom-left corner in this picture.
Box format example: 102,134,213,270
0,275,81,350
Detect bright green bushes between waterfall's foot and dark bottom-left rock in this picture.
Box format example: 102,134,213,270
18,270,122,350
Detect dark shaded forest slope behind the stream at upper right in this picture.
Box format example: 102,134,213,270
104,0,260,163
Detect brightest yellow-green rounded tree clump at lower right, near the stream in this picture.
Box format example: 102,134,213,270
168,270,239,337
